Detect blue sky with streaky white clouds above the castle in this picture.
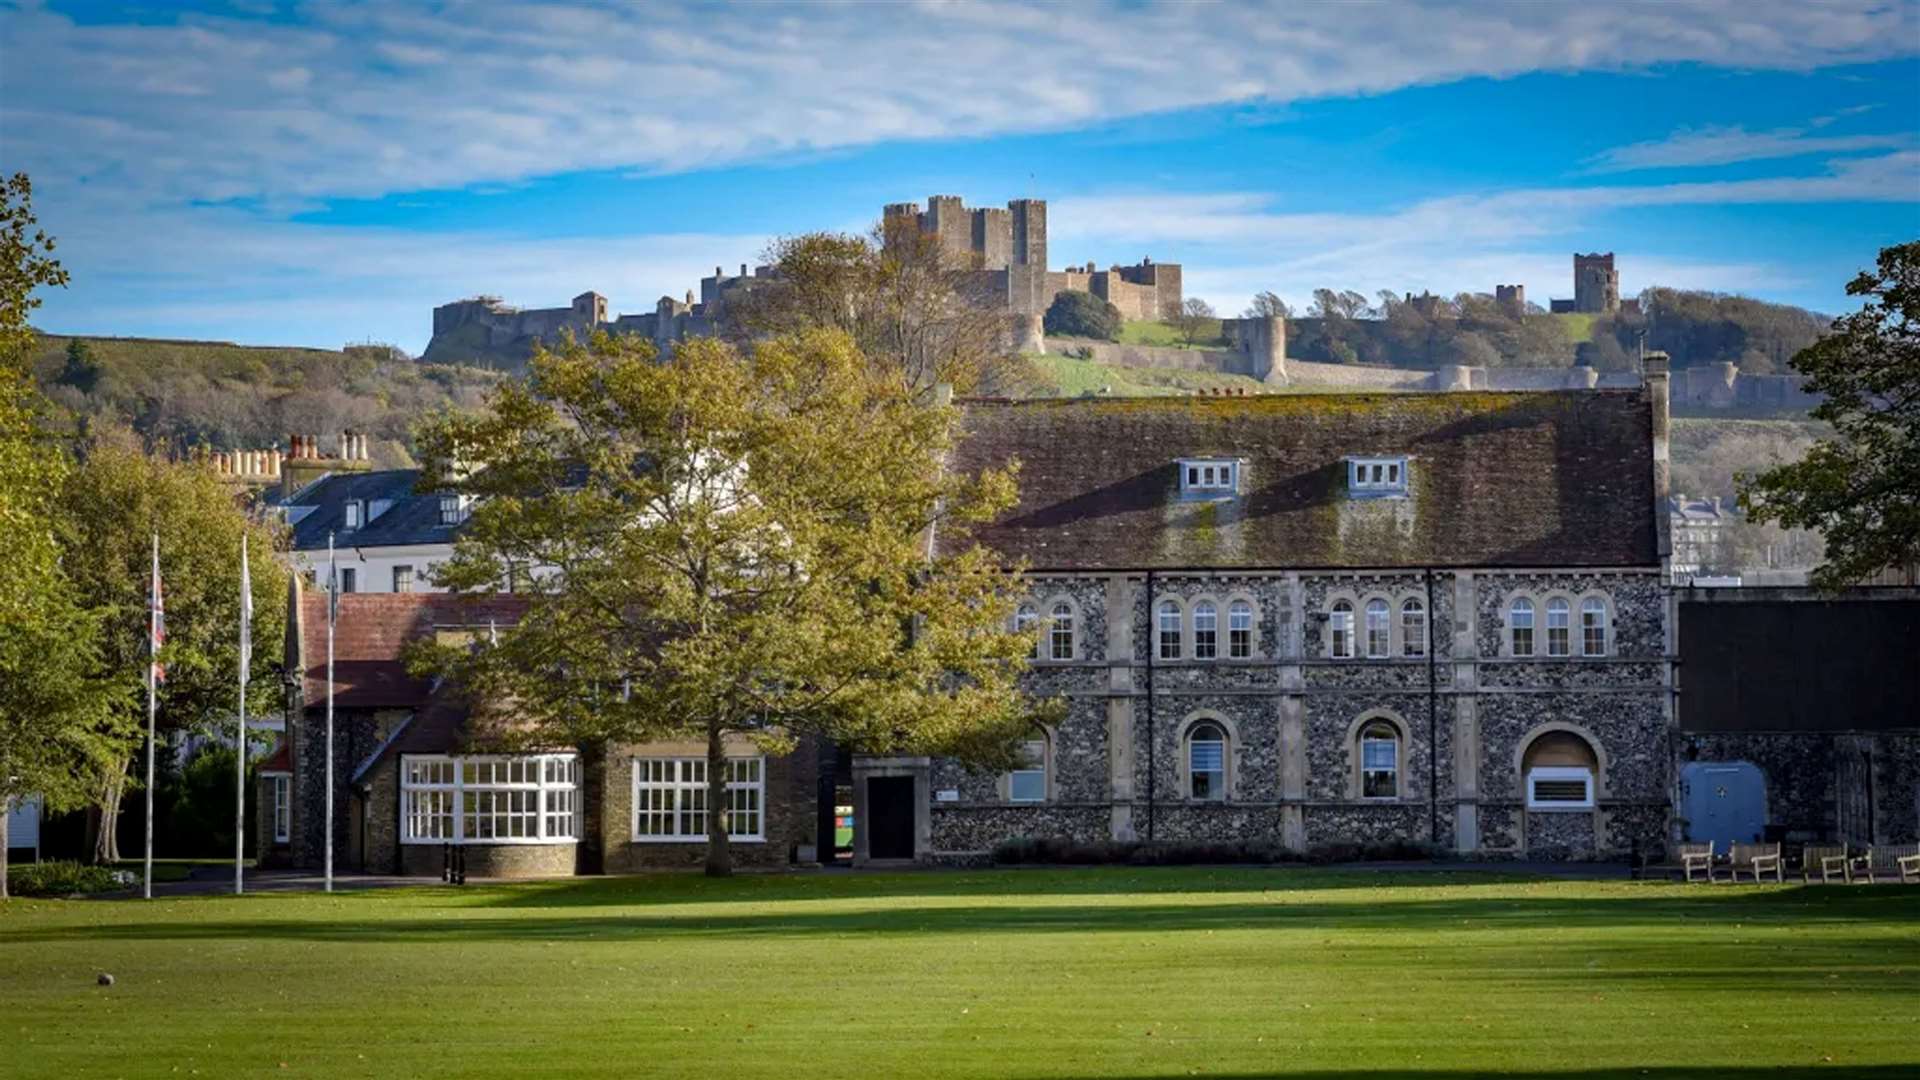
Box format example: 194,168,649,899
0,0,1920,352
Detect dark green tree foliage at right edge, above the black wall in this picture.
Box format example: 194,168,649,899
1740,240,1920,588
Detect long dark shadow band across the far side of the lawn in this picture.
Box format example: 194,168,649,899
8,890,1920,941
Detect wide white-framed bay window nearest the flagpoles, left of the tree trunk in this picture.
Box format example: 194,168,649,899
399,753,580,844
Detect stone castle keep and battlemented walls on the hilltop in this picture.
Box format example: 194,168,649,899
422,194,1183,365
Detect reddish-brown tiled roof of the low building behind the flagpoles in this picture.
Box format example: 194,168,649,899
300,590,526,709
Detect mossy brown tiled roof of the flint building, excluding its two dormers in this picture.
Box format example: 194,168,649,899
954,390,1659,571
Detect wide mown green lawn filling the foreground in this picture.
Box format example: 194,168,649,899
0,869,1920,1080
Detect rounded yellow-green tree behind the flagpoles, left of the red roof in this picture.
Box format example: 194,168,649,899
60,442,286,861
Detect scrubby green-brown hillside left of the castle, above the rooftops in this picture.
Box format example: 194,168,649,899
35,334,497,465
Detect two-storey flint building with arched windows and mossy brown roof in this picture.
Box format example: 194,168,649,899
871,359,1672,861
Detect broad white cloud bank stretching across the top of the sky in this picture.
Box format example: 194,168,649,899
11,0,1914,202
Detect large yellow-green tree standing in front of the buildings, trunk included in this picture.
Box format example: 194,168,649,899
420,329,1037,874
